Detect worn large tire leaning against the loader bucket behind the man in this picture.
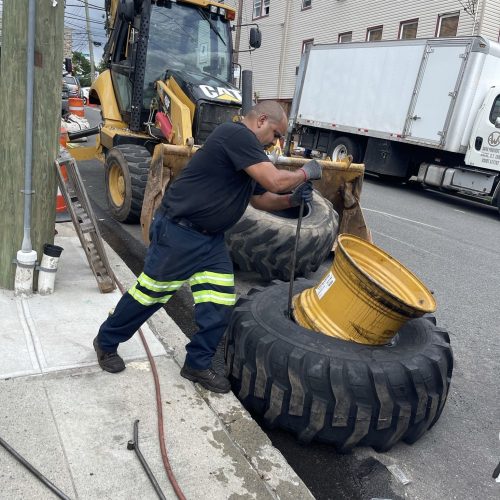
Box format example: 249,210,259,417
226,191,339,281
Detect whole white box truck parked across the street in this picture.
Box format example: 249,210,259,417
288,37,500,210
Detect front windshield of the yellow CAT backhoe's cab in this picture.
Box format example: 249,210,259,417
144,2,232,108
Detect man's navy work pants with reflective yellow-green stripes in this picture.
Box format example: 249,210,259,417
98,215,236,370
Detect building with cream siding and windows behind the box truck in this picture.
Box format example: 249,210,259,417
230,0,500,111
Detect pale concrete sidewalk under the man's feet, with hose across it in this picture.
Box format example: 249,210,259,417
0,224,312,500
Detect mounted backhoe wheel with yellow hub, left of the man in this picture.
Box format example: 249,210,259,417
105,144,151,223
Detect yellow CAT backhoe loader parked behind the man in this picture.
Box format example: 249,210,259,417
73,0,368,242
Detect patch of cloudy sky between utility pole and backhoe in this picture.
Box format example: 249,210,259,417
64,0,106,66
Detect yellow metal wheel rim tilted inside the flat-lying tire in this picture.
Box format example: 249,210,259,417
293,234,436,345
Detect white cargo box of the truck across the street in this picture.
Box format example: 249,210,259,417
291,37,500,153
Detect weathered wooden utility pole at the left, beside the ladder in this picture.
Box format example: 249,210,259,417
0,0,64,289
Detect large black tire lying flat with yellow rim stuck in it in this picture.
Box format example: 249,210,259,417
225,280,453,452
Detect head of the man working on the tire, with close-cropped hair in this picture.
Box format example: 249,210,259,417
243,101,287,146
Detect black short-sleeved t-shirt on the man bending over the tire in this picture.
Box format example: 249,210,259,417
162,123,269,233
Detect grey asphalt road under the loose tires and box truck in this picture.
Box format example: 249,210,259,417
76,106,500,500
